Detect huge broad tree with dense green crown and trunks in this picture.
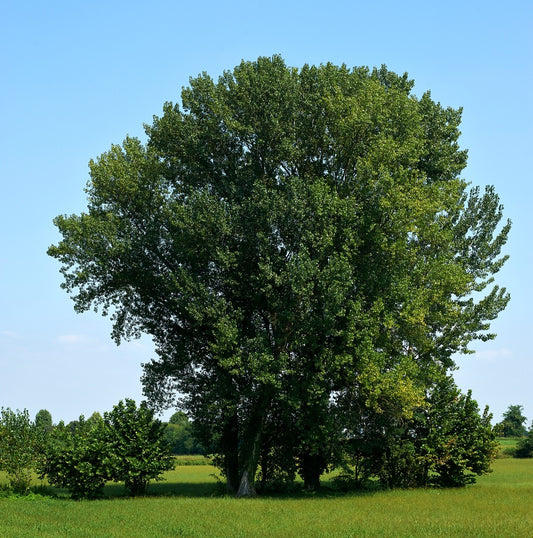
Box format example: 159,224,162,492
49,56,510,495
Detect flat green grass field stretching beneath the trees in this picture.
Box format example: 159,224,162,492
0,458,533,538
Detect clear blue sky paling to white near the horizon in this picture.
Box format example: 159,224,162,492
0,0,533,421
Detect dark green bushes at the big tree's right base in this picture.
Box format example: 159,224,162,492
339,375,497,488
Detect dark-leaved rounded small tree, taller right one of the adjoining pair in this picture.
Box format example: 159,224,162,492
104,399,174,495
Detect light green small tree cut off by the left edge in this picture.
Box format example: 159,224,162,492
0,407,37,493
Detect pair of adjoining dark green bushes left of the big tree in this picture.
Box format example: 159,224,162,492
40,399,174,498
